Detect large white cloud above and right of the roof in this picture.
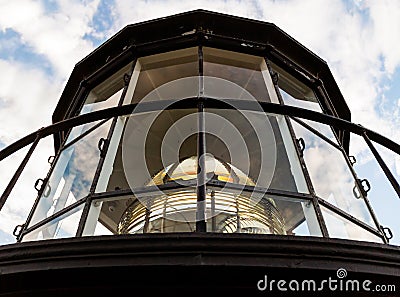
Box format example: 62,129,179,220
114,0,400,137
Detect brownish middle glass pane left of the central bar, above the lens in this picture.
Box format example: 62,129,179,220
96,109,198,192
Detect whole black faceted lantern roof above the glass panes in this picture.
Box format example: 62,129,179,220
53,10,351,126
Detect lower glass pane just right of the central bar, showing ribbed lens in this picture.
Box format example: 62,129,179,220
206,186,322,236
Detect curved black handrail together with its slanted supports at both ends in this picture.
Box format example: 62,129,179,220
0,97,400,210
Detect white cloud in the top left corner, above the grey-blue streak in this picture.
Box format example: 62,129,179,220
0,0,99,78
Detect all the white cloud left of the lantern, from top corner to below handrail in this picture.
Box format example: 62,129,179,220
0,0,103,242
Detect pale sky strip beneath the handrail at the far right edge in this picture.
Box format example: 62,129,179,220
350,134,400,245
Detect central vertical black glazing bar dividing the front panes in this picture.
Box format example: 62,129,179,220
196,46,207,232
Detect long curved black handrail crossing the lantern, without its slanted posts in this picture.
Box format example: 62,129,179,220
0,97,400,161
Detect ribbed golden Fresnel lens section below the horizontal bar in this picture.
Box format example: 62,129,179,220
118,189,286,235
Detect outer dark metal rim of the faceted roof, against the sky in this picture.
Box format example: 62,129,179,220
52,9,351,134
